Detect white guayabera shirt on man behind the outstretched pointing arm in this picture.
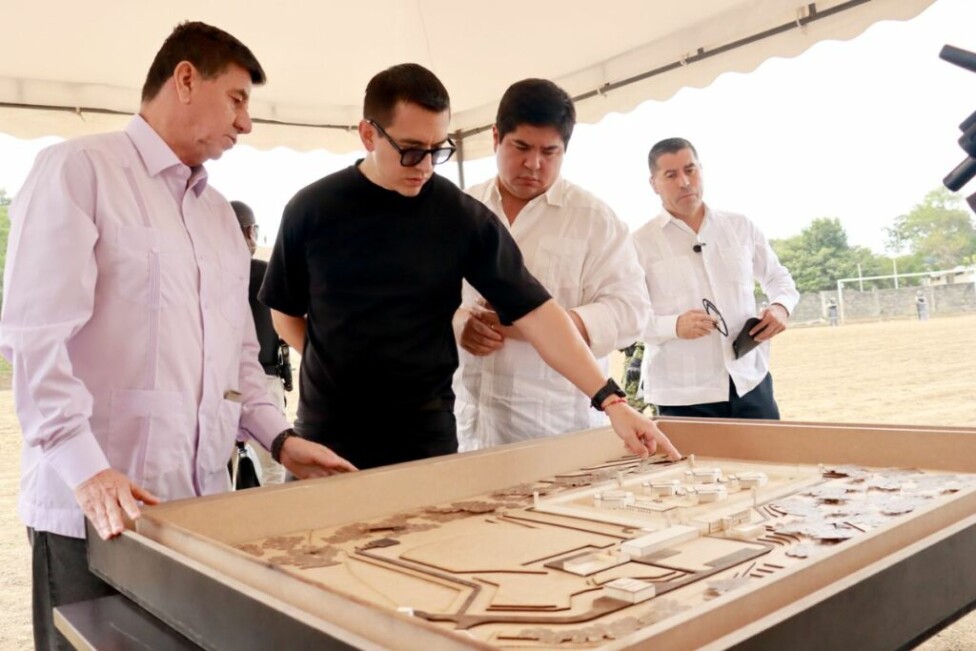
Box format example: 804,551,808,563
454,179,648,451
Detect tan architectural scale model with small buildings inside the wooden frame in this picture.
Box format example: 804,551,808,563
236,457,976,648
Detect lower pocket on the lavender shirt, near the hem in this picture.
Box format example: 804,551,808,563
106,389,190,486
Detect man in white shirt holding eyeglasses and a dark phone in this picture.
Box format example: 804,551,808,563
634,138,799,419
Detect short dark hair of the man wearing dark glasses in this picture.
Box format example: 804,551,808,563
363,63,451,128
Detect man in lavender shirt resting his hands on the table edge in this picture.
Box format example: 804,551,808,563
0,23,355,649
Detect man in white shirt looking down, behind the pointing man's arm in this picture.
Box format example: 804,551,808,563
454,79,648,451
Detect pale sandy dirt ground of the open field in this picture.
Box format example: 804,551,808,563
0,315,976,651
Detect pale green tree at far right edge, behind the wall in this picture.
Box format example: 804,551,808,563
886,187,976,269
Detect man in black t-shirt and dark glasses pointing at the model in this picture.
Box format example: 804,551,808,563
259,64,678,468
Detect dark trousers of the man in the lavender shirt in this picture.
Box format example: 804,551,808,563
27,527,116,651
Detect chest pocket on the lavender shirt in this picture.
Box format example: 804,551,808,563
99,224,198,309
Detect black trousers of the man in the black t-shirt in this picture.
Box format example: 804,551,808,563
295,409,457,470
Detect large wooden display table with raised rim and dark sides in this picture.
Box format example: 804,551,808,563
92,420,976,649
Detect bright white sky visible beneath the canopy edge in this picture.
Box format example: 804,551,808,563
0,0,976,252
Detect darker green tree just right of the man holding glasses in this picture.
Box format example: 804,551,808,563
770,217,891,292
